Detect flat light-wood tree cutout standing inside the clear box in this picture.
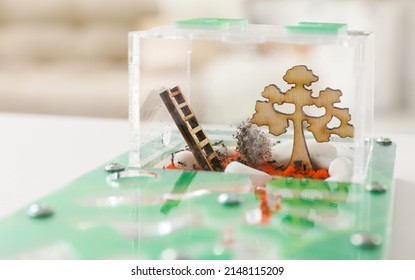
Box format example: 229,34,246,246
251,65,354,169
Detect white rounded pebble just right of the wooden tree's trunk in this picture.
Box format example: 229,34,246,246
307,141,337,169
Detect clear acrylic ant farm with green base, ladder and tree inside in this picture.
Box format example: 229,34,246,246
0,18,396,259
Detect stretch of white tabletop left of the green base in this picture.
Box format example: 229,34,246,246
0,113,129,219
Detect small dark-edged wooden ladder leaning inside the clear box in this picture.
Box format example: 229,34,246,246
160,86,223,171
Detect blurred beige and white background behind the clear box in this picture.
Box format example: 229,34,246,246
0,0,415,129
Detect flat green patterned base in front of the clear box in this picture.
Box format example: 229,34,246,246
0,143,396,259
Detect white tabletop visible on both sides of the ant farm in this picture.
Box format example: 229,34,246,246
0,113,415,259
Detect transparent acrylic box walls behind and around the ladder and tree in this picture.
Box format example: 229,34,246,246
129,19,373,185
